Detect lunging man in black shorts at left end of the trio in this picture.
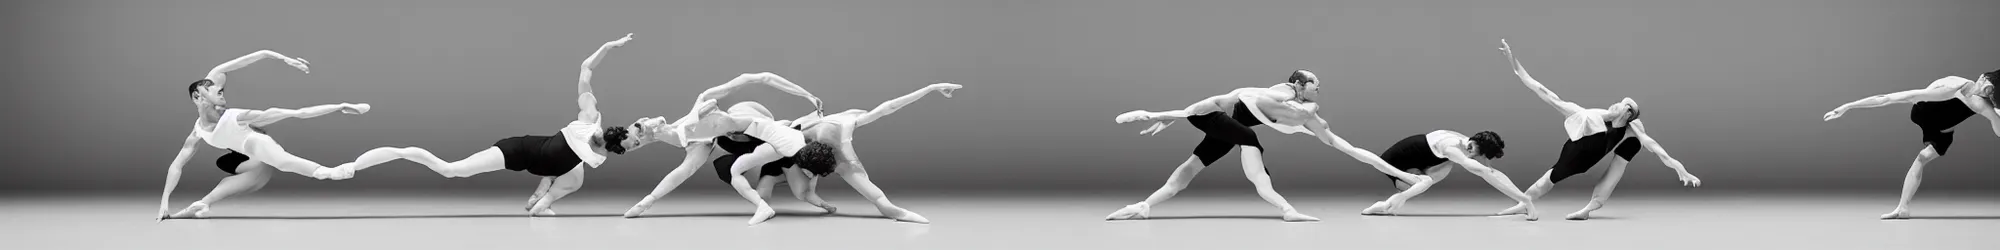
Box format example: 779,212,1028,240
1106,70,1432,222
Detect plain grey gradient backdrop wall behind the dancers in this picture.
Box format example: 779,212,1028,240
0,0,2000,191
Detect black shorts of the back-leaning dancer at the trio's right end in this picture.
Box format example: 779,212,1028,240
1548,128,1640,182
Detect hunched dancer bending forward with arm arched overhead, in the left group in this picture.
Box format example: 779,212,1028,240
624,72,834,224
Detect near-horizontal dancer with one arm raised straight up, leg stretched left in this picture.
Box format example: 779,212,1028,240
336,34,644,216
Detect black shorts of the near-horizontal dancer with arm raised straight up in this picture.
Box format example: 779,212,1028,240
494,136,584,176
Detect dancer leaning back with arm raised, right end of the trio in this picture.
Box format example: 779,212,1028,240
1500,40,1702,220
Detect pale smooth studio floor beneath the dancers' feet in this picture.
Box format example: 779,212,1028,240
0,188,2000,250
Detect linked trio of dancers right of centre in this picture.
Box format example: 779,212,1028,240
1106,40,1702,222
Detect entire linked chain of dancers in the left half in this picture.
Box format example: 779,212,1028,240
160,34,962,224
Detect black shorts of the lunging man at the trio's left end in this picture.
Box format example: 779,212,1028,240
1188,102,1264,166
